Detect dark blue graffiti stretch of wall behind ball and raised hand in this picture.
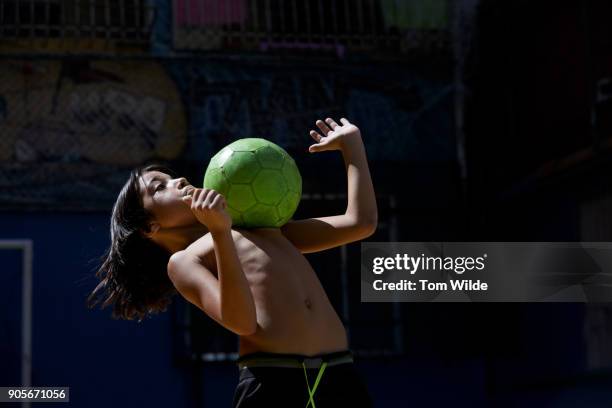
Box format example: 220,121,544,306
168,62,455,161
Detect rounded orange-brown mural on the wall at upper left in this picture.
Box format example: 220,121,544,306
0,60,187,208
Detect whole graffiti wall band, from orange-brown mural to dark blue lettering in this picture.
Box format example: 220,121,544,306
0,57,455,210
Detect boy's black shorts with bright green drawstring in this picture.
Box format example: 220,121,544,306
232,350,372,408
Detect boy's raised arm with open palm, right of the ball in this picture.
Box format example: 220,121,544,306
281,118,378,253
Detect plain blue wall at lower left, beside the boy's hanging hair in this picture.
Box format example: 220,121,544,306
0,213,189,408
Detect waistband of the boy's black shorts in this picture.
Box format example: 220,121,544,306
236,350,353,369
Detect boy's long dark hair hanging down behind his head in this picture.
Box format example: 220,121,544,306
87,164,176,321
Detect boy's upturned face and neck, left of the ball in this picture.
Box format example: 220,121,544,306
139,171,198,233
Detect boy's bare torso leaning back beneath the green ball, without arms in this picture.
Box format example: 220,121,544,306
196,228,348,355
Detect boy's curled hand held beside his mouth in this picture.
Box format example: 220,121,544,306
182,188,232,233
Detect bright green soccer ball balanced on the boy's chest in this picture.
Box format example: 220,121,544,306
204,138,302,228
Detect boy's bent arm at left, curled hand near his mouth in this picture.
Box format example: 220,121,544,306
168,189,257,336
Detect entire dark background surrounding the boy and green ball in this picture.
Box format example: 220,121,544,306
0,0,612,407
